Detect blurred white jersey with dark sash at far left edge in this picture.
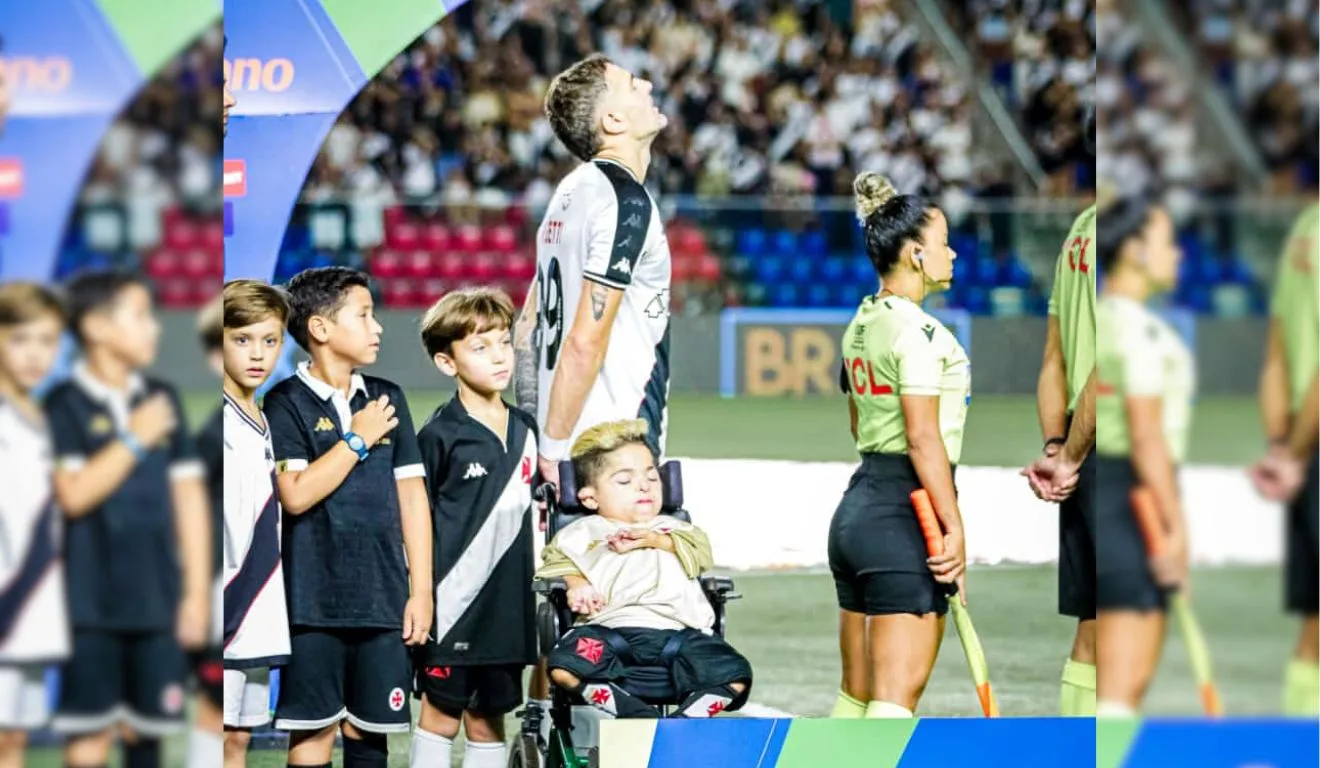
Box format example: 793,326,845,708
0,400,69,665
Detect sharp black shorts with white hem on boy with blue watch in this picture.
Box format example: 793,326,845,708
275,627,413,734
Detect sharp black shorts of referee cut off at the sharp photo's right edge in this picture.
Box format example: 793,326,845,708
1059,447,1096,620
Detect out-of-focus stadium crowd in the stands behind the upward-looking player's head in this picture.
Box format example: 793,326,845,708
306,0,973,207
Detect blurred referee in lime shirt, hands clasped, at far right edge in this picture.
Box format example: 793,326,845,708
1251,203,1320,717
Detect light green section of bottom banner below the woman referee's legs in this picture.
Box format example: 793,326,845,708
775,718,917,768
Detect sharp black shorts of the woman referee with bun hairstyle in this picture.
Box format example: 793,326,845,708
829,454,957,616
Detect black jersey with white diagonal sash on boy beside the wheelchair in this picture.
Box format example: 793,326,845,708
417,396,536,665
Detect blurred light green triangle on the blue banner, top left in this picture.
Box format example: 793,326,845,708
96,0,220,80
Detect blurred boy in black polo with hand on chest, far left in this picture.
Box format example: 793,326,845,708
45,272,211,768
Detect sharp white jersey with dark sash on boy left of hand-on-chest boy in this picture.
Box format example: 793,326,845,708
222,395,289,669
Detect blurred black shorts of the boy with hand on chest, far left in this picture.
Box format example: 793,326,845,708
51,629,186,736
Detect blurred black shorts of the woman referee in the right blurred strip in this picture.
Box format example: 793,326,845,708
1096,457,1167,611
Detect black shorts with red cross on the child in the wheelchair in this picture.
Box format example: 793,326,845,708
546,624,751,711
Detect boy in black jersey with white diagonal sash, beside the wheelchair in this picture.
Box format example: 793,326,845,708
412,288,536,768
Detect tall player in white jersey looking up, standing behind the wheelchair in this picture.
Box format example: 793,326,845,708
513,55,671,738
